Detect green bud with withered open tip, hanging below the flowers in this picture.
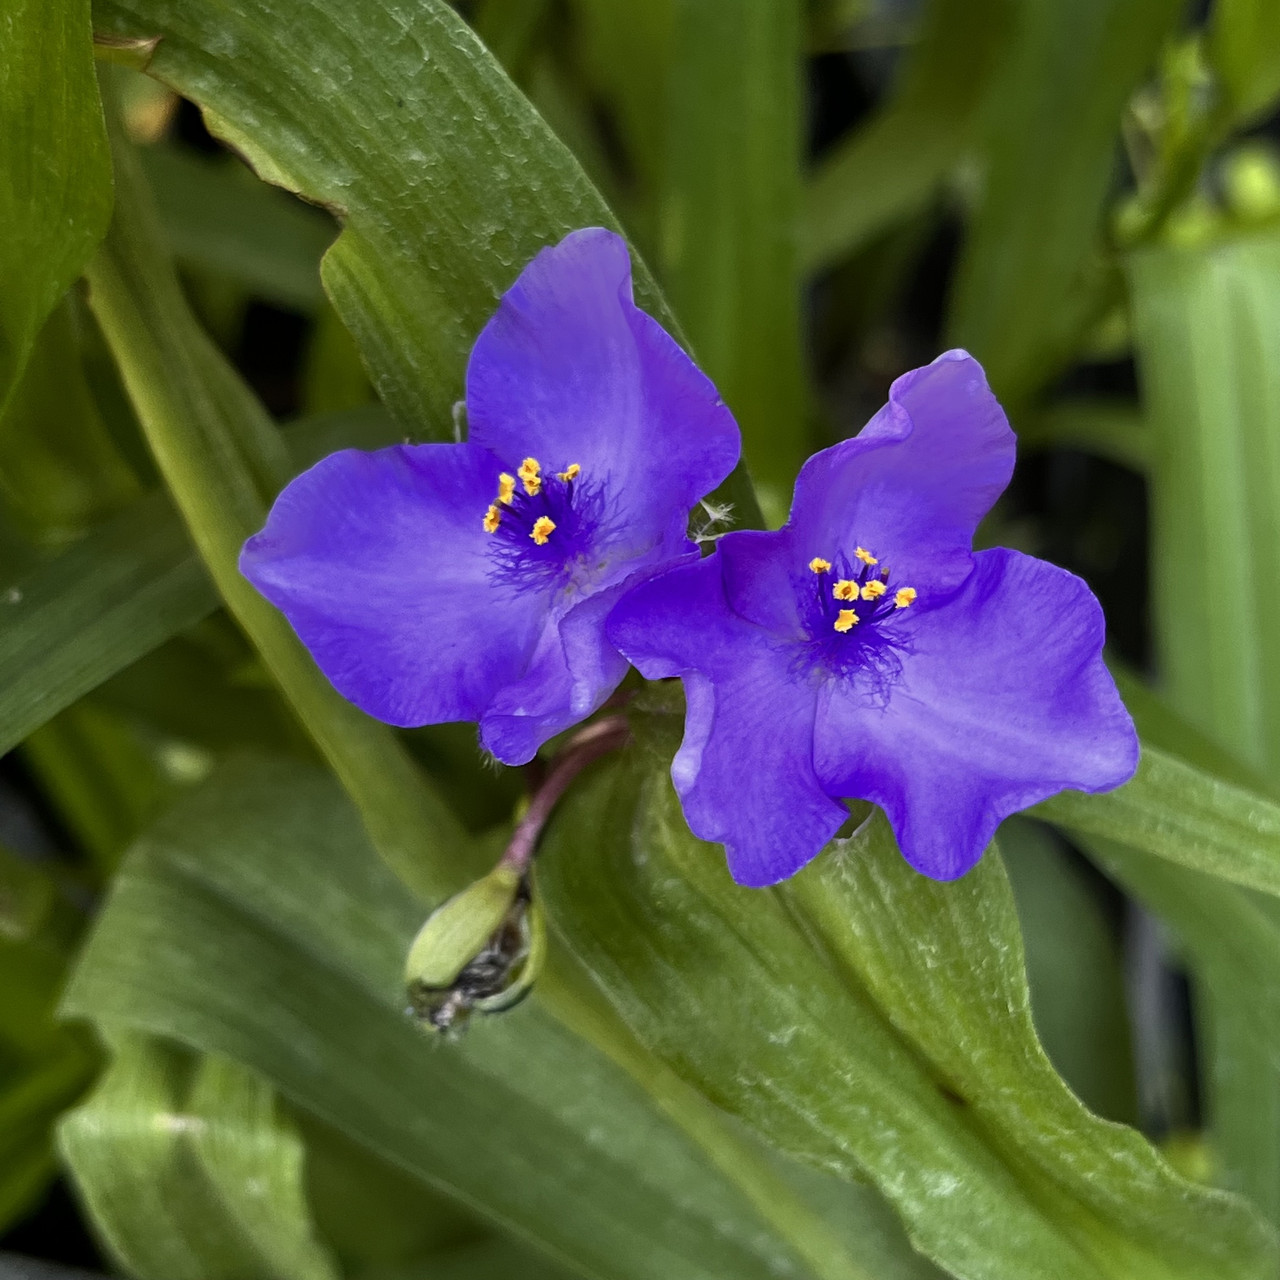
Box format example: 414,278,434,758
404,865,547,1030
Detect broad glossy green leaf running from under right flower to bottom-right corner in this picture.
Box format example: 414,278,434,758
541,732,1276,1280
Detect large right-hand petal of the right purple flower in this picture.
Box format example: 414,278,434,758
814,548,1138,879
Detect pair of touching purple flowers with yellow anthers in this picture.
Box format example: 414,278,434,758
241,229,1137,886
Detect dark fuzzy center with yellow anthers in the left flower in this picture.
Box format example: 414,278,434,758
483,458,603,585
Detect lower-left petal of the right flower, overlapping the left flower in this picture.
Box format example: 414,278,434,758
608,556,847,887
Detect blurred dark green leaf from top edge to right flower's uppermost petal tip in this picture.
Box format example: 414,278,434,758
948,0,1183,402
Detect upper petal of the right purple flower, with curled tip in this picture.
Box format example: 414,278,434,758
726,351,1015,628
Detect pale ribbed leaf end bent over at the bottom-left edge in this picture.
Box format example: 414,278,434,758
59,1036,335,1280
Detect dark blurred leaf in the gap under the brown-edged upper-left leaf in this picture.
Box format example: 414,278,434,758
141,145,335,311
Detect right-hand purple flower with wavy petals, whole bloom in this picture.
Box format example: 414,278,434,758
609,351,1138,886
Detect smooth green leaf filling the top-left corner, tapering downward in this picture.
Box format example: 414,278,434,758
0,0,111,413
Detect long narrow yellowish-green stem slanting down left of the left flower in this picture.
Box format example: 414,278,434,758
87,87,470,899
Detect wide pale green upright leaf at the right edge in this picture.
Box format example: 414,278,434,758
1129,234,1280,777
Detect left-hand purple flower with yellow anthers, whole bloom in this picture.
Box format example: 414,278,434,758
241,228,739,764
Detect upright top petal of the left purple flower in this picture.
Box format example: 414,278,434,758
467,227,740,545
